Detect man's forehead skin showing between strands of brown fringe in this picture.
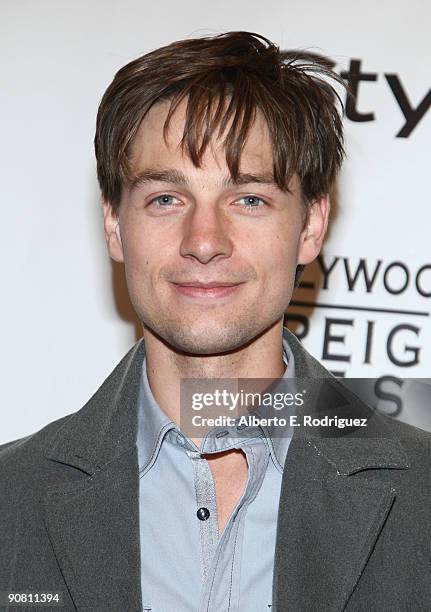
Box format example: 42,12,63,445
130,99,273,174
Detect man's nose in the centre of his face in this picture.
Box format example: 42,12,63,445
180,202,233,263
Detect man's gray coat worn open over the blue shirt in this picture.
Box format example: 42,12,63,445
0,334,431,612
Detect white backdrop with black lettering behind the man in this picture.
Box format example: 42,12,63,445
0,0,431,443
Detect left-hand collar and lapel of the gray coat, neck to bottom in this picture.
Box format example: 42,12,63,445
44,340,145,612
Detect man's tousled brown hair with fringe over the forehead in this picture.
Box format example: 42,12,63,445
94,32,344,282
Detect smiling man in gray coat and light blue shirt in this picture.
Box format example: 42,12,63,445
0,32,431,612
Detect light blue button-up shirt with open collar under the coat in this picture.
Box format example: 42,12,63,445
137,331,295,612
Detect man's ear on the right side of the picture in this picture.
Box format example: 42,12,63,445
297,195,331,265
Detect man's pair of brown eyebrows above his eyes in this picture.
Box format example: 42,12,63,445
130,168,276,189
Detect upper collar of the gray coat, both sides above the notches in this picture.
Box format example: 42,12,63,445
46,327,408,475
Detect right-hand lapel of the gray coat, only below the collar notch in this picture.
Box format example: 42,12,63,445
273,440,402,612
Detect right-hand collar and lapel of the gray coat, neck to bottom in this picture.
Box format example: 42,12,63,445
273,334,408,612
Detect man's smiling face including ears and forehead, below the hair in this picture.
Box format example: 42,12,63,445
104,97,328,355
